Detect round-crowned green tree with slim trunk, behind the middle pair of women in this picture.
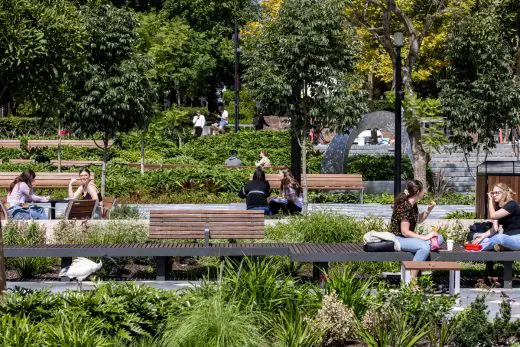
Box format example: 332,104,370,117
244,0,366,212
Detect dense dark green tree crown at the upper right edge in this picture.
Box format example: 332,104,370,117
440,4,520,151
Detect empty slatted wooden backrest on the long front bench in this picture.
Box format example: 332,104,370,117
149,210,264,239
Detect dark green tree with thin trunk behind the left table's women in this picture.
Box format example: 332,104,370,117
66,5,157,195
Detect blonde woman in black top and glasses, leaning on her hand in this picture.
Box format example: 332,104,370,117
473,183,520,252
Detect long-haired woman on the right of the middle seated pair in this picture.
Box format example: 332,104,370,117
269,169,303,215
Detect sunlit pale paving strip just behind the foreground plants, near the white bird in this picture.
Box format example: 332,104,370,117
3,281,520,319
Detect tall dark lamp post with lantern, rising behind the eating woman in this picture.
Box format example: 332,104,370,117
394,32,404,197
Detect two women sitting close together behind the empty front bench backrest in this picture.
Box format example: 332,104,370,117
238,166,303,215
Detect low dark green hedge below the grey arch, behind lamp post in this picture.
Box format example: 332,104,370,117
347,155,413,181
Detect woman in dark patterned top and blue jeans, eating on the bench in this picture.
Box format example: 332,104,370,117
390,180,444,278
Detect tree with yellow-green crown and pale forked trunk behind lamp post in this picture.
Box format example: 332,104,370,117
347,0,473,185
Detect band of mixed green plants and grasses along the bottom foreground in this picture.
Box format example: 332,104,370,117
0,258,520,347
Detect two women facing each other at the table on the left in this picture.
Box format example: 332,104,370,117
7,168,103,220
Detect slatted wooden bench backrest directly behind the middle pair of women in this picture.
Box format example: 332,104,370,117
265,174,363,190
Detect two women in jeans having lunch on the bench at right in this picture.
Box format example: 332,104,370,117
390,180,520,277
